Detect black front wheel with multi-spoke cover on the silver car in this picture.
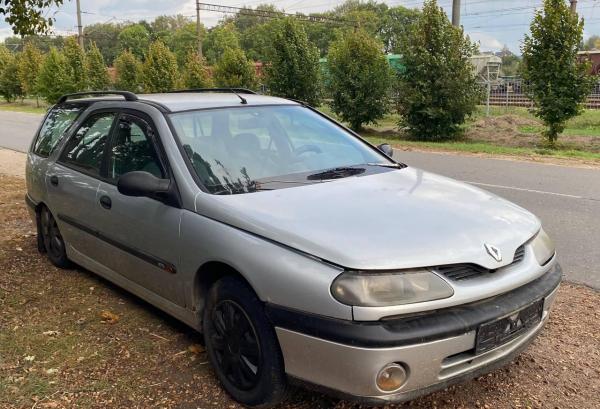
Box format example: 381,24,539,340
203,277,287,408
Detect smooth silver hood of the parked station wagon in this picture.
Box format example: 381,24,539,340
196,167,540,270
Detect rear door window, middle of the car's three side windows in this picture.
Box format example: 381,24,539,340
61,112,116,175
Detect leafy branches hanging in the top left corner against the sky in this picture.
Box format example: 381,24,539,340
0,0,63,35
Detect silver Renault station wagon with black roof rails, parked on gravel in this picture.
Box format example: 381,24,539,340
26,89,562,407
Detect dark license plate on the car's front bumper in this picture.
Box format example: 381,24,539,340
475,300,544,354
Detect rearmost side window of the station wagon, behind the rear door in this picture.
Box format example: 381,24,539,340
33,105,85,157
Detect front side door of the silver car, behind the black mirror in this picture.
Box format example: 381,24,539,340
94,112,183,304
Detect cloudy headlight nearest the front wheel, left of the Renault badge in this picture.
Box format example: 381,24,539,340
331,270,454,307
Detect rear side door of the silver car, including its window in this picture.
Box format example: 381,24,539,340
45,112,117,258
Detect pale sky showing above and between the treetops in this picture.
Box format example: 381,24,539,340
0,0,600,54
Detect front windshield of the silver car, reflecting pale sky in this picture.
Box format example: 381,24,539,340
171,105,394,194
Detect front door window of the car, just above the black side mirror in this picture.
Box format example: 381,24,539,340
108,115,165,181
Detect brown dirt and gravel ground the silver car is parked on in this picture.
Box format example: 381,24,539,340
0,165,600,409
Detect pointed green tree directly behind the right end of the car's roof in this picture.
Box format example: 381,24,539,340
266,17,321,106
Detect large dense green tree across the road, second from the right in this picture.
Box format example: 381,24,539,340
398,0,481,140
